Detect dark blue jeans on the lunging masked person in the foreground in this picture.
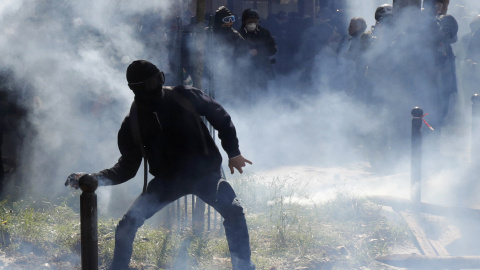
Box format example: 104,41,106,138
111,170,255,270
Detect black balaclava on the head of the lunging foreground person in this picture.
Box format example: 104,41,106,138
126,60,164,103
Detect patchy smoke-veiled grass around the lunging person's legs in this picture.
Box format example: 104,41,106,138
0,172,409,270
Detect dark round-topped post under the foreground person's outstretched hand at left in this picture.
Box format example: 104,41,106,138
78,175,98,270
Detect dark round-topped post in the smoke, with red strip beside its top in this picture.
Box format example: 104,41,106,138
410,107,423,206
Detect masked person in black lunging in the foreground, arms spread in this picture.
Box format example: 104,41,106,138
65,60,255,270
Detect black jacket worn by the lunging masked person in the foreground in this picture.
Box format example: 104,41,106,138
96,86,240,185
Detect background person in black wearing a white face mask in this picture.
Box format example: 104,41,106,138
239,9,277,96
